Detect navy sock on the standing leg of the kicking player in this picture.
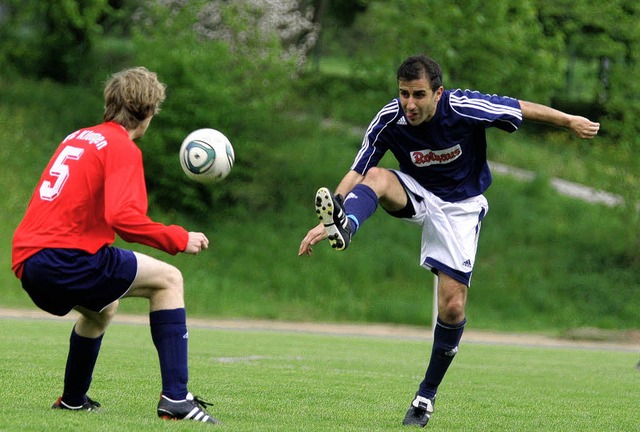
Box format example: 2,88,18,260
418,318,467,399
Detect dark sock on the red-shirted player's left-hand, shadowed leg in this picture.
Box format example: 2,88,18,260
62,327,104,406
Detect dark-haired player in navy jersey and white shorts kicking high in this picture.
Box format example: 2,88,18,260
298,55,600,427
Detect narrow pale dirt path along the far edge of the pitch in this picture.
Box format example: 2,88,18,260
0,307,640,353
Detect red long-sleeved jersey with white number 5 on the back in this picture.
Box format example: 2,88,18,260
12,122,189,278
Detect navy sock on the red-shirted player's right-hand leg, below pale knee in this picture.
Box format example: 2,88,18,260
149,308,189,400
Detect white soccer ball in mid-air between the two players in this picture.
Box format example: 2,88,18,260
180,129,235,183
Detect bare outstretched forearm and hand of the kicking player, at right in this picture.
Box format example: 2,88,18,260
519,101,600,139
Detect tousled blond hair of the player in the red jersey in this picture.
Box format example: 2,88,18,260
103,67,167,130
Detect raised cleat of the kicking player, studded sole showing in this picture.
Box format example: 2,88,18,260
316,187,352,250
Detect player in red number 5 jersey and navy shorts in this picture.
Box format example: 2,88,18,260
12,67,218,423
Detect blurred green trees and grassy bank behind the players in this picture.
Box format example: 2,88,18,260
0,0,640,331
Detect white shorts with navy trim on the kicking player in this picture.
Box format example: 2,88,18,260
392,170,489,286
